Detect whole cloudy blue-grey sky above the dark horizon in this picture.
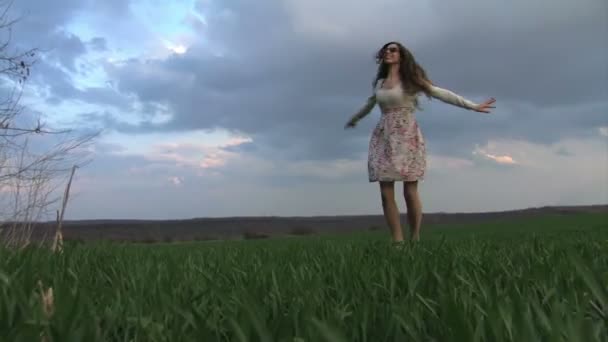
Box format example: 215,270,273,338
3,0,608,219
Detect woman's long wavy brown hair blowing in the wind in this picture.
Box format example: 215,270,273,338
374,42,432,97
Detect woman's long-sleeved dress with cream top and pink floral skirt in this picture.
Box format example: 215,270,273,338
351,80,477,182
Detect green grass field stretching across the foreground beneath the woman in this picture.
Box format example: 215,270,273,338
0,214,608,342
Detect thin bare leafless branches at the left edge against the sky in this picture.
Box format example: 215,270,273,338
0,3,98,247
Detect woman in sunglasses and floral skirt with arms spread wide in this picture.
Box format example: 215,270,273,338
345,42,496,243
